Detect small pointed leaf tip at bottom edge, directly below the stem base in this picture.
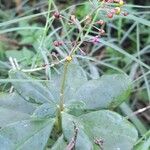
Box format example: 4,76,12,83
51,135,67,150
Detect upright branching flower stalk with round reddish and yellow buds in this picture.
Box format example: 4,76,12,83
54,0,127,133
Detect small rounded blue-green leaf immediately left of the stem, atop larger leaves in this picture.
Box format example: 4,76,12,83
32,103,56,119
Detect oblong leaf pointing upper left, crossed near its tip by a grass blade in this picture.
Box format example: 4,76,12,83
9,70,54,104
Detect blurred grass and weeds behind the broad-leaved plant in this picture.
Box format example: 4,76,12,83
0,0,150,149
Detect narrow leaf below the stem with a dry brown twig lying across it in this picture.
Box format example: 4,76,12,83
62,113,93,150
